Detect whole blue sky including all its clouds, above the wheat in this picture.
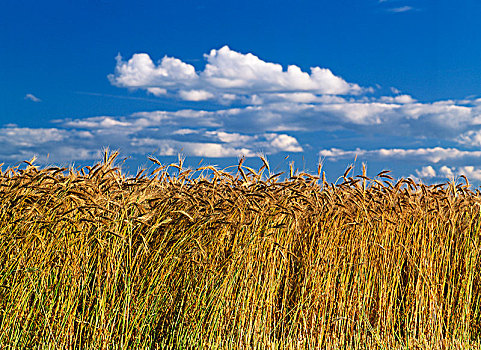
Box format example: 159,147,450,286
0,0,481,182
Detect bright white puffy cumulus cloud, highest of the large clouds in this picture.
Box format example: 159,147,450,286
109,46,365,102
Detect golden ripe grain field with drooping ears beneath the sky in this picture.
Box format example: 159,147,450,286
0,153,481,349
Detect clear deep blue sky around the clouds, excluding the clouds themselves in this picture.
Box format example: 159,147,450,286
0,0,481,180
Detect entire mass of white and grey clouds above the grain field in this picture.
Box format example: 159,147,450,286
5,46,481,180
